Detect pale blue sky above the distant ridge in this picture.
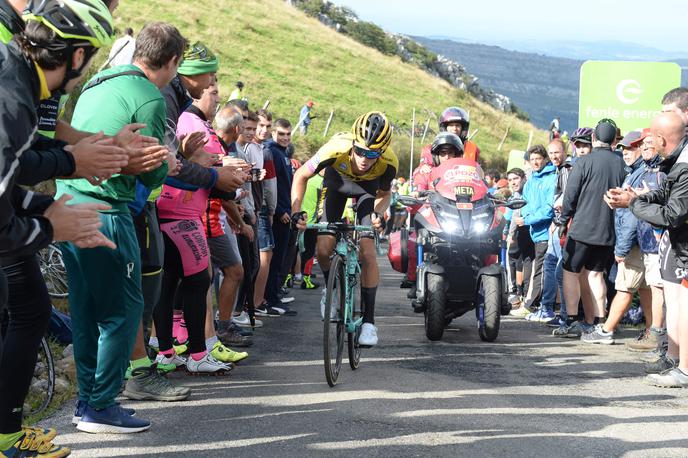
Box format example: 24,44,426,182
334,0,688,54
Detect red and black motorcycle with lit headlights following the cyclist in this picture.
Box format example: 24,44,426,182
390,158,526,342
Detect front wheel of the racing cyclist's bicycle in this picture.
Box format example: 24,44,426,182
323,255,346,386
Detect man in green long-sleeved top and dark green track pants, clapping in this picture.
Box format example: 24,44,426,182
57,22,187,433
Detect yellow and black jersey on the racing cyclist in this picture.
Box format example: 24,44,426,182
304,133,399,191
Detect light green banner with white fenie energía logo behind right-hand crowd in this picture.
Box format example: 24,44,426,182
578,61,681,134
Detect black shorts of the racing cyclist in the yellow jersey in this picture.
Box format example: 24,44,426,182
316,167,380,236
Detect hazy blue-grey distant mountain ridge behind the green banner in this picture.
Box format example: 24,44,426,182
413,37,688,132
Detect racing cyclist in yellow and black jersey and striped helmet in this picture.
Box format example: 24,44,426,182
291,111,399,346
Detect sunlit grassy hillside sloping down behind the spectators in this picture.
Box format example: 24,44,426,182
115,0,544,171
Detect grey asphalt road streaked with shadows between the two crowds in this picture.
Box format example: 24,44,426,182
45,260,688,458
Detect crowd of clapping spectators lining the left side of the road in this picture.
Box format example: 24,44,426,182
0,0,319,457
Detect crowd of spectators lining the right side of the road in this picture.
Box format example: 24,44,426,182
500,93,688,388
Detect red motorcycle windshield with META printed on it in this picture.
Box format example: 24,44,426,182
431,158,487,202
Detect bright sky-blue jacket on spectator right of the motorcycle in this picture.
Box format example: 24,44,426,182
521,162,557,242
